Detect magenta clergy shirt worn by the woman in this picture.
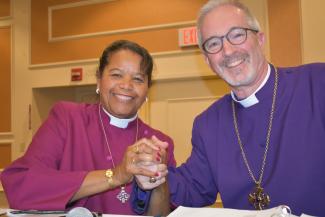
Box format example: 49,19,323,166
1,102,175,214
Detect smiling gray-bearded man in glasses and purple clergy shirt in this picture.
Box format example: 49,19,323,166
135,0,325,216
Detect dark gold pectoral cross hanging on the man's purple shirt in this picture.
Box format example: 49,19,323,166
248,184,270,210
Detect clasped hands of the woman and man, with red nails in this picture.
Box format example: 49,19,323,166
116,136,168,190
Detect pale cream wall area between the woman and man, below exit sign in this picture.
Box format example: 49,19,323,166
149,79,229,165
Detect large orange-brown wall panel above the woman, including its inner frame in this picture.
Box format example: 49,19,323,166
31,0,205,64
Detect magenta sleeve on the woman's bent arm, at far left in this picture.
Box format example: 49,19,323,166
1,102,87,210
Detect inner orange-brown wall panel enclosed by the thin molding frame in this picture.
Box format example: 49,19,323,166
49,0,197,37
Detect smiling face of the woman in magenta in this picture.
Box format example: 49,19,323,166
97,49,148,118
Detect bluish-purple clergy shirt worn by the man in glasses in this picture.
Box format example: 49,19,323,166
168,63,325,216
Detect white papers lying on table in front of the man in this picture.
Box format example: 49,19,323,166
168,206,308,217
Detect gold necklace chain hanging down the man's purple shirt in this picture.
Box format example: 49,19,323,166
231,68,278,186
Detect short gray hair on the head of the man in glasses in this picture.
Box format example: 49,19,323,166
197,0,260,49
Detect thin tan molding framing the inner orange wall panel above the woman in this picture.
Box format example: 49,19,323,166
48,0,196,42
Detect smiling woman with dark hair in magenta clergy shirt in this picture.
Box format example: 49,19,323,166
1,40,175,214
